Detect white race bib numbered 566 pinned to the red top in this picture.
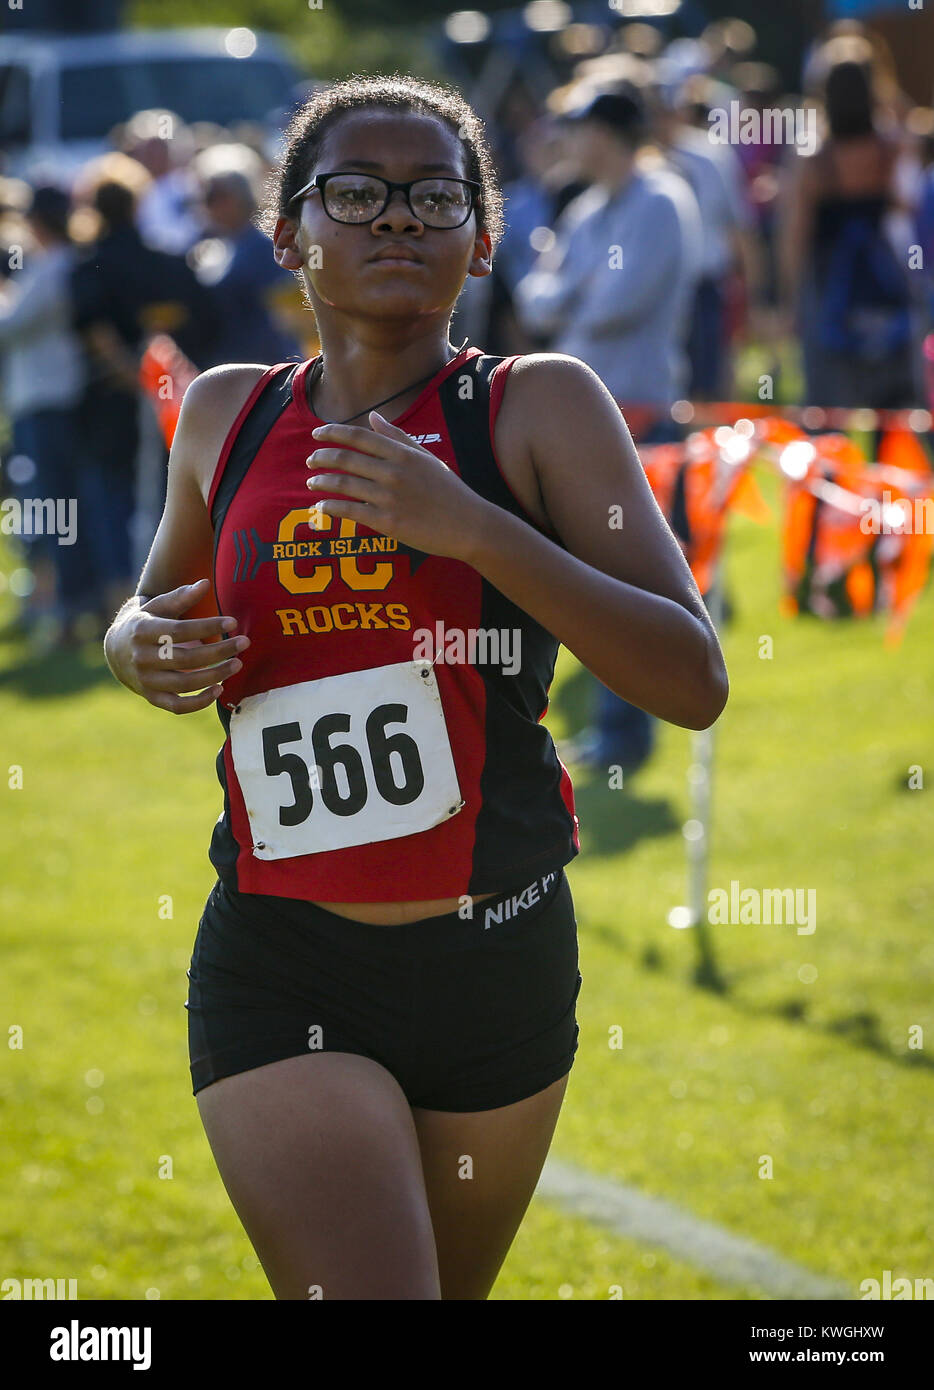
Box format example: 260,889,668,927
231,660,464,859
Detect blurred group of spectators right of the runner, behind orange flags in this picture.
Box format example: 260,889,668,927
454,19,934,771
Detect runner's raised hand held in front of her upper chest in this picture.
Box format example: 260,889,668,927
306,410,492,560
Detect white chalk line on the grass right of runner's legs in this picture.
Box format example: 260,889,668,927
535,1156,856,1301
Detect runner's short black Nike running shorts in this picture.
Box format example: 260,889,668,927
185,869,581,1111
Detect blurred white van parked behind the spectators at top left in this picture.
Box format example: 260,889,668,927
0,28,302,182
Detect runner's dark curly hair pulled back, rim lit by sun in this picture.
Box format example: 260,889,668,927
259,72,503,249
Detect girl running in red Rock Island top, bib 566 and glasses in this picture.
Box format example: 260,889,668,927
106,76,727,1300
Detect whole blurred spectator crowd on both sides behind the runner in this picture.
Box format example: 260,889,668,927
0,19,934,769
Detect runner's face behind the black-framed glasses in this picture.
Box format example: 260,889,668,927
287,110,489,318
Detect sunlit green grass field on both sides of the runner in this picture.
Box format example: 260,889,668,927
0,464,934,1300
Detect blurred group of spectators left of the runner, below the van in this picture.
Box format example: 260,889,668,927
0,110,314,648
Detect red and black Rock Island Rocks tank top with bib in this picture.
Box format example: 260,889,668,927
207,348,580,902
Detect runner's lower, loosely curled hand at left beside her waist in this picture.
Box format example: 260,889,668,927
108,580,250,714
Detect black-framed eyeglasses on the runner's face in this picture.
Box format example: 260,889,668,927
289,171,481,231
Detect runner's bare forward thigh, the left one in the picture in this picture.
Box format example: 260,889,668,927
196,1052,441,1300
